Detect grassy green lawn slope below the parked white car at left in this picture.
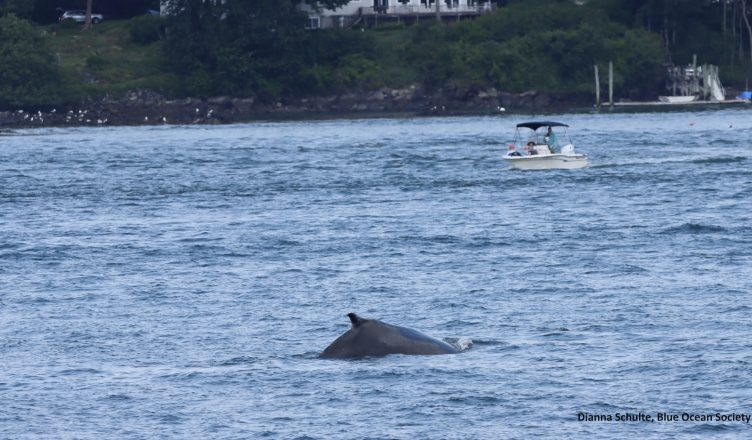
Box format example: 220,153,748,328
46,20,169,96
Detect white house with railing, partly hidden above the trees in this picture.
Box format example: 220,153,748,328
302,0,495,28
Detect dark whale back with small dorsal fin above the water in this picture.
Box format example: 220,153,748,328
320,313,459,358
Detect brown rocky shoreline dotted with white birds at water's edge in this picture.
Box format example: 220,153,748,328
0,86,592,128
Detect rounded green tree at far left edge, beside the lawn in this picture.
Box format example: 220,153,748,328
0,14,60,108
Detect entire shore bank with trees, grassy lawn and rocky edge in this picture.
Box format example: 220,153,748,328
0,0,752,128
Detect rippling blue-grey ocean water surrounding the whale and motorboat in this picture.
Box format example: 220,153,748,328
0,108,752,439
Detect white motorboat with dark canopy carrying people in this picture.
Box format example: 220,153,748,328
504,121,587,170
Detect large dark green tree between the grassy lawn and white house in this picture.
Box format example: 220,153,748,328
164,0,347,96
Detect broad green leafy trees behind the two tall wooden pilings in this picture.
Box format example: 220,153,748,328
409,0,663,96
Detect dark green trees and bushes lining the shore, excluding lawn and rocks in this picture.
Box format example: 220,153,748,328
0,0,752,106
